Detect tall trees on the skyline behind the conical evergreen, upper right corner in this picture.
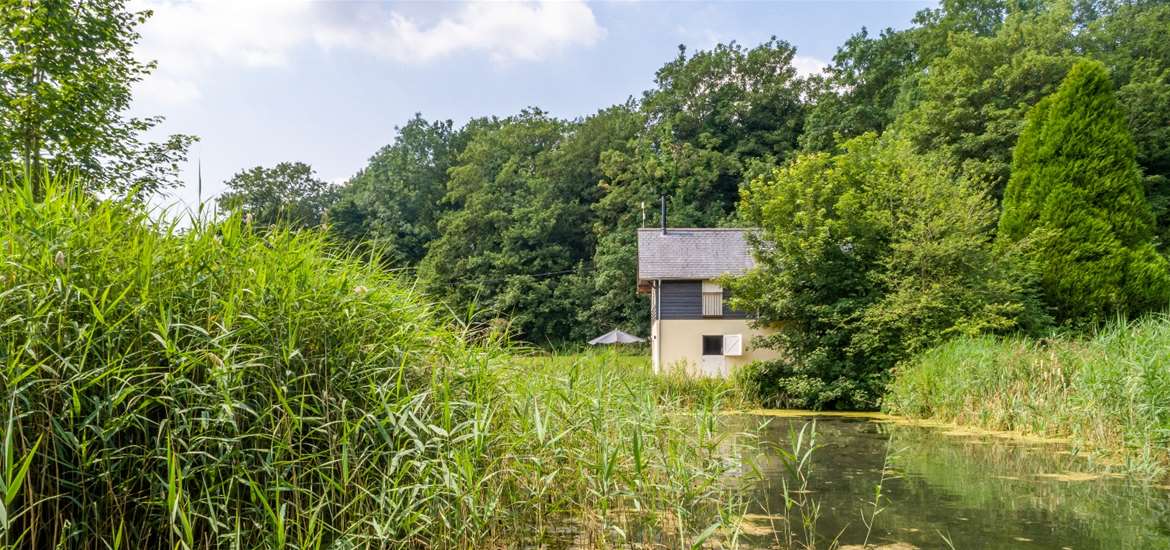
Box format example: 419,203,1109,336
800,0,1170,214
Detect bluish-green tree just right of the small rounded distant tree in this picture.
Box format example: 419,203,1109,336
330,114,472,266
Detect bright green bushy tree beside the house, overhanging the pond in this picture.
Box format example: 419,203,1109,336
730,135,1046,408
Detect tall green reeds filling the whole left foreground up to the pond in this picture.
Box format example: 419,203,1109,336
0,181,737,549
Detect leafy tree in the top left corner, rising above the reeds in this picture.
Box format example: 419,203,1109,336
0,0,194,193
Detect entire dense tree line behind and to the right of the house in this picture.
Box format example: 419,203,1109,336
215,0,1170,407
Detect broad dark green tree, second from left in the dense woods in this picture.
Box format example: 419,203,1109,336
419,110,583,343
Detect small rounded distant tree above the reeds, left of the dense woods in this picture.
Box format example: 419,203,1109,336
218,163,337,227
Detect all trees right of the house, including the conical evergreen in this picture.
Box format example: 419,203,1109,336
731,1,1170,407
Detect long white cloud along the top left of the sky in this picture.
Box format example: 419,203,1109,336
132,0,605,103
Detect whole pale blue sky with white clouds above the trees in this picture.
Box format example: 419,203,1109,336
131,0,932,212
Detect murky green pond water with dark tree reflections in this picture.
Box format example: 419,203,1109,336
728,414,1170,550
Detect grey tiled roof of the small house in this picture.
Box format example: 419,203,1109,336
638,228,756,281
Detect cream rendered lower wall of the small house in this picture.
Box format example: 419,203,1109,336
651,318,777,376
